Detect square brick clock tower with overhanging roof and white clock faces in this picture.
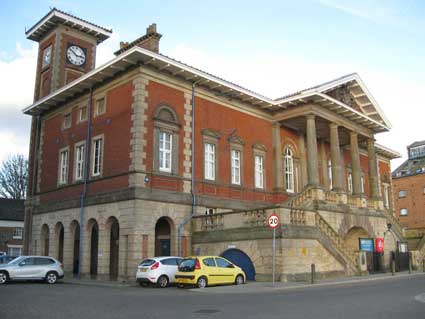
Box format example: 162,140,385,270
26,8,112,101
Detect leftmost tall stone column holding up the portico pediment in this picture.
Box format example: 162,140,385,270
306,114,319,186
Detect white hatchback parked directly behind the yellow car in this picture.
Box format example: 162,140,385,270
136,256,183,288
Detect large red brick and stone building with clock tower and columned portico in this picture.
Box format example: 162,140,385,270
24,9,402,280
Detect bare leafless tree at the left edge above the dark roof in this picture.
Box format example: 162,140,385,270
0,154,28,199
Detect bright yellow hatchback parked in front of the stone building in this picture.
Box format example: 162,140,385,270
175,256,246,288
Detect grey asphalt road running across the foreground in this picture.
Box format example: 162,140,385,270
0,276,425,319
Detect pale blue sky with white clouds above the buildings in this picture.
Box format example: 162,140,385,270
0,0,425,169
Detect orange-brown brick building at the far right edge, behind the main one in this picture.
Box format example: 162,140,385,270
392,141,425,258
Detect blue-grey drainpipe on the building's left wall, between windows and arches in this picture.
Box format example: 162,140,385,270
78,87,93,279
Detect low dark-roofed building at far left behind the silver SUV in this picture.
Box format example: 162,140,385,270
0,198,25,256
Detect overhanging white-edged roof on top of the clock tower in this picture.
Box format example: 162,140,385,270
25,8,112,43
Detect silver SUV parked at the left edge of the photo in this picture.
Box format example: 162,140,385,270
0,256,64,285
